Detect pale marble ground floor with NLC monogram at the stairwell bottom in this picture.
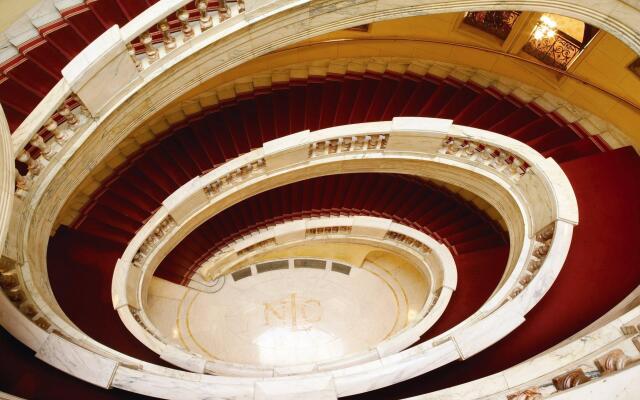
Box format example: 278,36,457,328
149,268,407,366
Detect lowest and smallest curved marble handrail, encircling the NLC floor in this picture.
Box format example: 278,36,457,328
112,216,457,376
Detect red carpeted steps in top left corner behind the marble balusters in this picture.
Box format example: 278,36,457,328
0,0,228,132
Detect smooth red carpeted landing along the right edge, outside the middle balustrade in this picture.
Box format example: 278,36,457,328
345,147,640,400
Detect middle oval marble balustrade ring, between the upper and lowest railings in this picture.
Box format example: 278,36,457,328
96,118,577,395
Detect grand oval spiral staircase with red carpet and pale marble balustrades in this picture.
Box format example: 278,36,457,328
0,0,640,400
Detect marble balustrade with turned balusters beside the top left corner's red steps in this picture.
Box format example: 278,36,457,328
13,0,250,198
